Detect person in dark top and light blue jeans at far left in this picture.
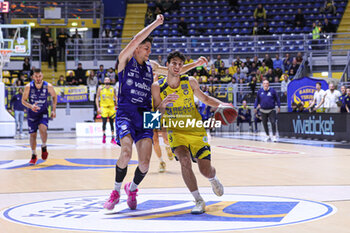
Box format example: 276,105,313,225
10,88,25,138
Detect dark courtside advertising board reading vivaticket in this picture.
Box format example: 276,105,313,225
278,112,350,141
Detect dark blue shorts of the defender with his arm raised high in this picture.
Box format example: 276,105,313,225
116,109,153,143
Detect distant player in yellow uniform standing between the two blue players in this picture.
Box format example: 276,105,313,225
96,77,118,144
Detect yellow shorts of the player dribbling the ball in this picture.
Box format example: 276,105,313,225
168,130,211,162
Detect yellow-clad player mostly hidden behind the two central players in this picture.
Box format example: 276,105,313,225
153,74,174,173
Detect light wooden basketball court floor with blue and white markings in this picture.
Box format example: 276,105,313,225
0,133,350,233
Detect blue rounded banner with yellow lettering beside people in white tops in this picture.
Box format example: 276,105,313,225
287,77,328,112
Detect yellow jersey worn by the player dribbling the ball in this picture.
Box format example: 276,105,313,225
158,75,204,134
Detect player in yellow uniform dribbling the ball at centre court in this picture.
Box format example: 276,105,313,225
152,51,224,214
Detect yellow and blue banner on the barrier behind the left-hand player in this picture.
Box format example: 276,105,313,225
55,86,88,103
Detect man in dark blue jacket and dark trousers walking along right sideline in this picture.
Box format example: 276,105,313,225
254,80,281,142
